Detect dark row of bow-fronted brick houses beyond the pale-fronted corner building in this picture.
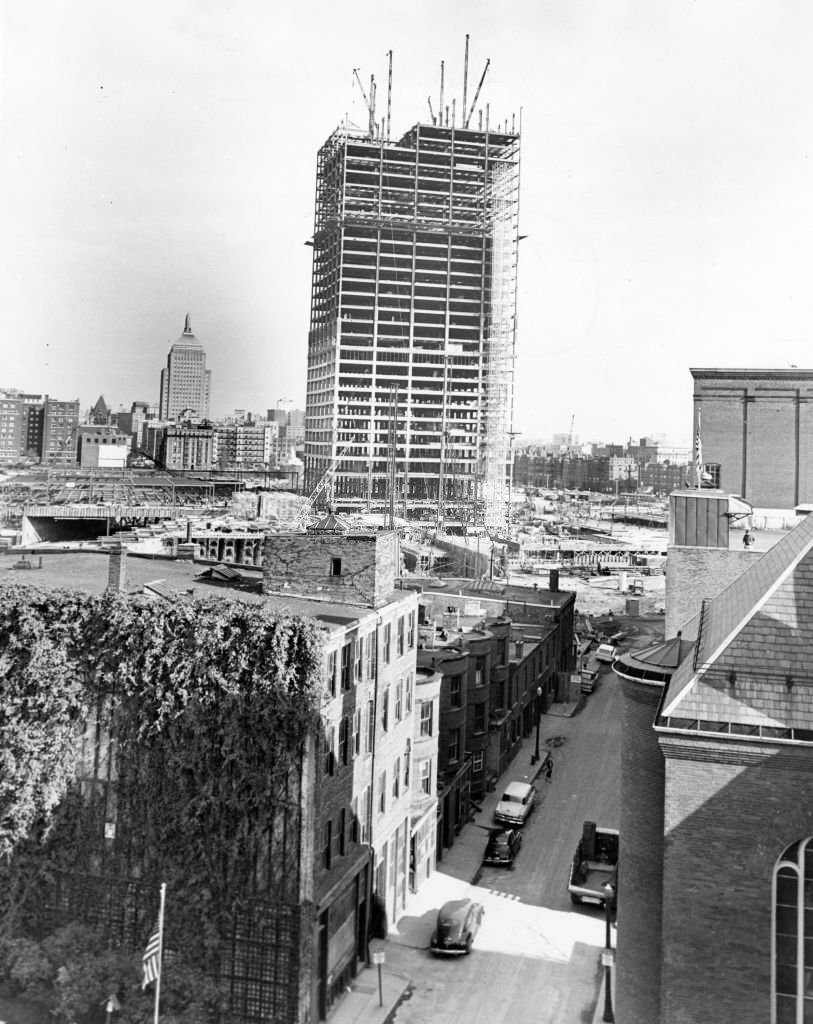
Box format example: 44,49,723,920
418,581,575,857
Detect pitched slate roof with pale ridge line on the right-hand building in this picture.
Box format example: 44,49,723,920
657,515,813,735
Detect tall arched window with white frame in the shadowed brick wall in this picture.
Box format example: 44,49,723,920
771,838,813,1024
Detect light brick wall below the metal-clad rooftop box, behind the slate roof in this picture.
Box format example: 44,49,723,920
666,545,762,639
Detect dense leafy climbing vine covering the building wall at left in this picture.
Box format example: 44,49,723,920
0,587,322,963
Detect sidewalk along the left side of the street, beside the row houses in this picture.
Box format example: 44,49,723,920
328,705,581,1024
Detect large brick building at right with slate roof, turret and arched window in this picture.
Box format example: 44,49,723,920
616,490,813,1024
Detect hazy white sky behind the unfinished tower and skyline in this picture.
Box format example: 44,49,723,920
0,0,813,443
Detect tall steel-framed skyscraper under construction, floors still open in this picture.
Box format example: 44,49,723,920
305,104,519,530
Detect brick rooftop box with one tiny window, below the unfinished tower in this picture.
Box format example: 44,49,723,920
263,532,397,608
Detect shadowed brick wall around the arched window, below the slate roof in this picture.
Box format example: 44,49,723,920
659,734,813,1024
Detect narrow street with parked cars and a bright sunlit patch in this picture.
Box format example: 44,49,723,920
387,655,621,1024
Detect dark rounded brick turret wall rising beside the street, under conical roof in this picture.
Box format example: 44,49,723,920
615,679,664,1024
